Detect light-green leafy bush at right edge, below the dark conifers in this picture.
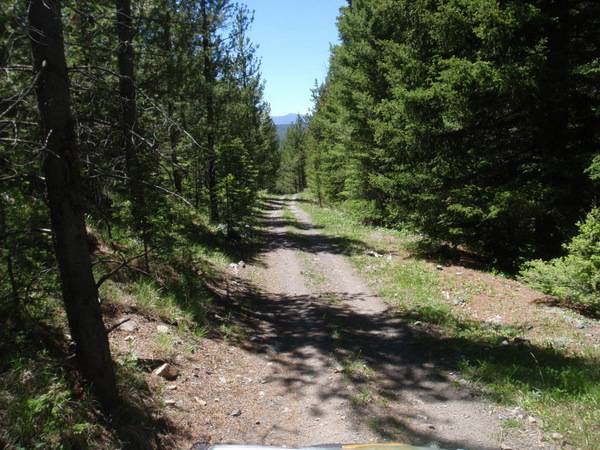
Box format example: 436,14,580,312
521,208,600,312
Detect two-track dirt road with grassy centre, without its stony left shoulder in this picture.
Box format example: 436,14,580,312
239,199,545,450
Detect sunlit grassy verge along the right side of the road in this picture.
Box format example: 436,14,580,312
299,192,600,450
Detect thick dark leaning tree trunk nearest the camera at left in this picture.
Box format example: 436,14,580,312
28,0,119,410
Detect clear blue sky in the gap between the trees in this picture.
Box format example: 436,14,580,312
240,0,348,116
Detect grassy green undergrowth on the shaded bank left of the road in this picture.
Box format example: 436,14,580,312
0,199,259,449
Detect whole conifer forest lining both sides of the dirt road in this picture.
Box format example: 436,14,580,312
0,0,600,443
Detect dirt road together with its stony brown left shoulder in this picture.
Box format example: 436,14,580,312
137,195,557,450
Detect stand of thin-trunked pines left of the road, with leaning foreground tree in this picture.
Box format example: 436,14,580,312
0,0,279,410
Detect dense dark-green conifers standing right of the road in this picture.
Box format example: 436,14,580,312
305,0,600,269
